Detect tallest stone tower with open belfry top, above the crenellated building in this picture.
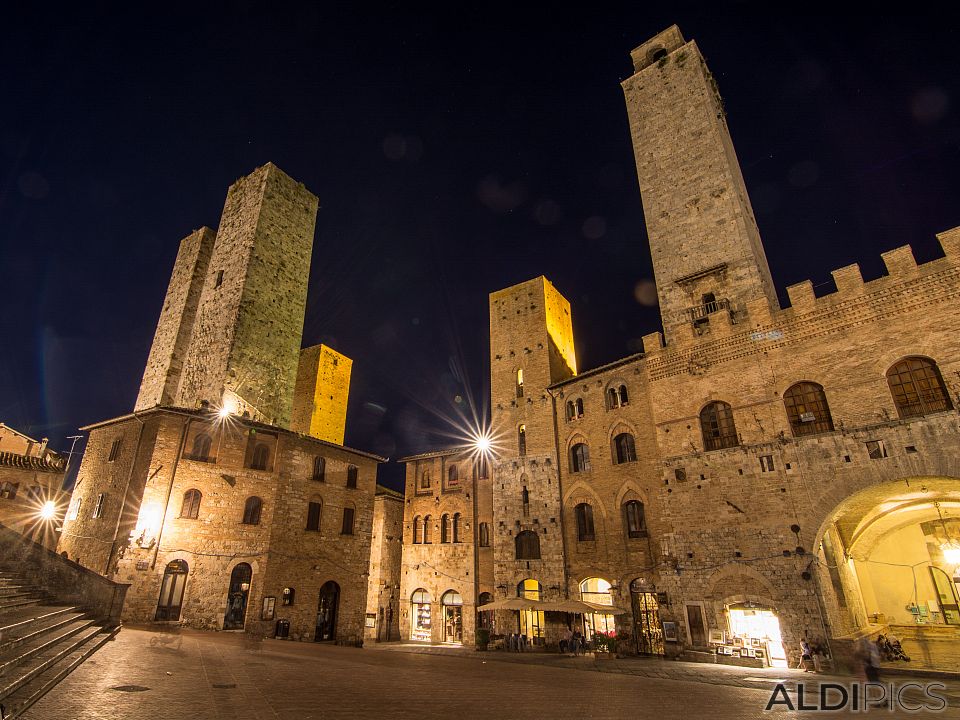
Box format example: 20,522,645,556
623,26,777,342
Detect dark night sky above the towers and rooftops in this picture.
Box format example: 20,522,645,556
0,2,960,490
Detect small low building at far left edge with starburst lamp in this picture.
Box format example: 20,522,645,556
0,423,68,550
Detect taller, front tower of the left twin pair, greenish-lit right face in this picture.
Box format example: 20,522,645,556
176,163,317,427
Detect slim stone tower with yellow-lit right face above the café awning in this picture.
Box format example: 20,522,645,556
490,276,577,599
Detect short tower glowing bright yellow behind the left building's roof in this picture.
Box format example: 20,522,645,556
290,345,353,445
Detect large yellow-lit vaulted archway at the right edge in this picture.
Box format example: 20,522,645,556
816,477,960,668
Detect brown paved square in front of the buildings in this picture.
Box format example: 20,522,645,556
25,628,960,720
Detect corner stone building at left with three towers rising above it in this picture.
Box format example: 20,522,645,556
58,164,383,643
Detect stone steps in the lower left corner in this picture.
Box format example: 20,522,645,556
0,565,120,720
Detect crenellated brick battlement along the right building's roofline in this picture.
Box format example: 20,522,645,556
784,227,960,313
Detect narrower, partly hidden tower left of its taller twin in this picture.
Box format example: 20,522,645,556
134,227,217,410
